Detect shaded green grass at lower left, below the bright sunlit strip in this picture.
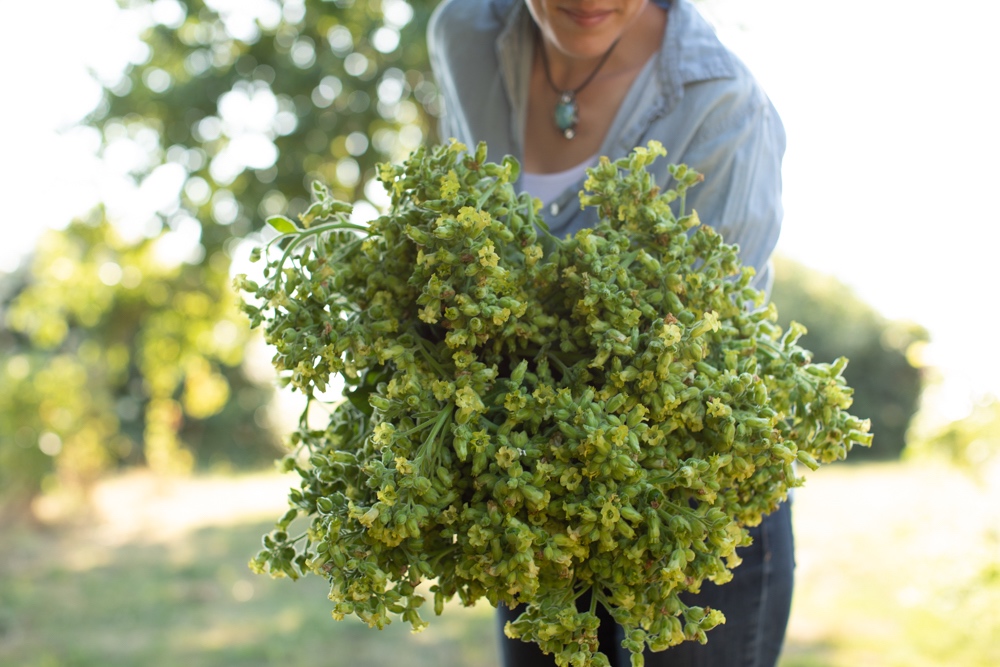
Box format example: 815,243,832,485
0,523,494,667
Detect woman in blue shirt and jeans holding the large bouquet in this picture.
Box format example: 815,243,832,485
428,0,794,667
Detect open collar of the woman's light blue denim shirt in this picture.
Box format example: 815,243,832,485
492,0,737,161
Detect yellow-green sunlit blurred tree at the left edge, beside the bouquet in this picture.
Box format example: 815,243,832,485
0,217,277,512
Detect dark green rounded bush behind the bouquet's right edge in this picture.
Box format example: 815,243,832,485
771,257,928,461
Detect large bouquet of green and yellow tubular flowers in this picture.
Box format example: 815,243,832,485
237,142,871,667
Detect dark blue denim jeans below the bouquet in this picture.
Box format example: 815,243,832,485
498,502,795,667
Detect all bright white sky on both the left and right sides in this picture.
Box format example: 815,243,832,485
0,0,1000,426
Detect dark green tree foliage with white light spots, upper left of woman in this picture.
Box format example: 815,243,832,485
100,0,436,239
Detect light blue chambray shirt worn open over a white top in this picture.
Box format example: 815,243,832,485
428,0,785,289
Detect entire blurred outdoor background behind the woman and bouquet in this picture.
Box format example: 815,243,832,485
0,0,1000,667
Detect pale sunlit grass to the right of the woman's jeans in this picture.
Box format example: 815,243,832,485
782,464,1000,667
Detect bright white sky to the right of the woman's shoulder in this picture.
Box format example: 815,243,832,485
705,0,1000,417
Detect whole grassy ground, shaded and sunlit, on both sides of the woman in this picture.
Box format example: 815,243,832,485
0,464,1000,667
